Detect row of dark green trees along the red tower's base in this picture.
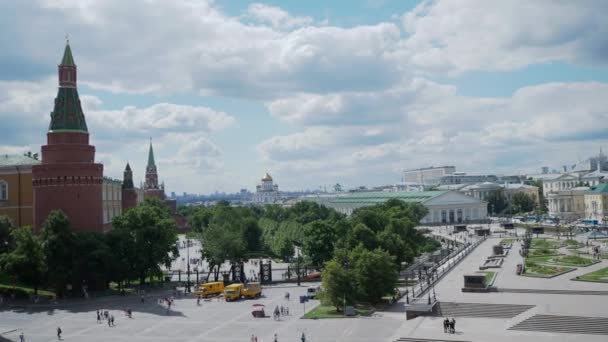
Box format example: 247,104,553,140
0,200,177,296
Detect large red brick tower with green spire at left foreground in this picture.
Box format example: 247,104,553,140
32,42,103,232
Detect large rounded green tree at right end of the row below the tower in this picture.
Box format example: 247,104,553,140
112,199,178,285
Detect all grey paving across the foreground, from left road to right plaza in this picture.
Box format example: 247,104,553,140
0,228,608,342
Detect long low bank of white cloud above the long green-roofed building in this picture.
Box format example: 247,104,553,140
258,79,608,188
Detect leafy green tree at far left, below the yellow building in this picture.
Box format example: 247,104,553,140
0,227,45,294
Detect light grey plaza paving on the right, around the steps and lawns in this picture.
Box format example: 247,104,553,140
389,231,608,342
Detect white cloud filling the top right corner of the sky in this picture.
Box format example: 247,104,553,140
400,0,608,72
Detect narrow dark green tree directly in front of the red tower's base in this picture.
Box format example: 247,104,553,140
41,210,75,296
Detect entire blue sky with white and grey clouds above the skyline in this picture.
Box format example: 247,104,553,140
0,0,608,193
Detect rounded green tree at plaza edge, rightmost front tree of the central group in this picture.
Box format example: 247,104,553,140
350,247,398,304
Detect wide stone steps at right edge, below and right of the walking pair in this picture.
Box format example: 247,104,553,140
509,315,608,335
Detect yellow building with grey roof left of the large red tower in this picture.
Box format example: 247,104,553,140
0,154,40,227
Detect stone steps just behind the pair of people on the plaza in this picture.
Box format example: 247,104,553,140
433,302,534,318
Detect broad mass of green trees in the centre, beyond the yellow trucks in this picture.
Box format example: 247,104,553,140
184,200,439,304
